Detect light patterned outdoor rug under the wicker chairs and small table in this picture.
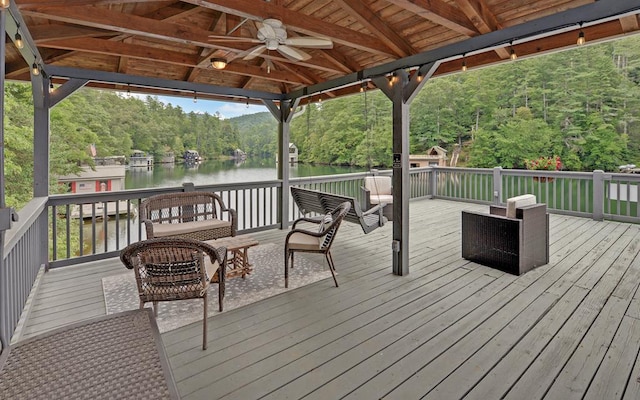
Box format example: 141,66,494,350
102,243,333,332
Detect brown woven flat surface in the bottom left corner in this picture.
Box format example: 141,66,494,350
0,309,179,400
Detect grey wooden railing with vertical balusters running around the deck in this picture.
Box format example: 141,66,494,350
0,167,640,344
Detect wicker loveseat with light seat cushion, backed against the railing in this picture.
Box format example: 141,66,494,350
140,192,238,241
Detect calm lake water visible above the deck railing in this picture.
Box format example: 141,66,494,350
125,159,366,189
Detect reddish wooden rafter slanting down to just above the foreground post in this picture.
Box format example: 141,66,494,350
333,0,417,57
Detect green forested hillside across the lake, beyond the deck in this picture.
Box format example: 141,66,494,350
5,36,640,205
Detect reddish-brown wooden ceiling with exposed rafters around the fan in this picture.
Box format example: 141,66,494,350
6,0,640,100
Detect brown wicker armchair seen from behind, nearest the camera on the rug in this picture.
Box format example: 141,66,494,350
120,238,227,350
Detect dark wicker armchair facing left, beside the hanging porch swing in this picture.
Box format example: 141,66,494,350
284,201,351,287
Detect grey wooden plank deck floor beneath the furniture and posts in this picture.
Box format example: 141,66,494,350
17,200,640,400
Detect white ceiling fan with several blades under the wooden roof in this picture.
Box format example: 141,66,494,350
209,18,333,61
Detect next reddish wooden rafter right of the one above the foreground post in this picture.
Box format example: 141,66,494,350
387,0,479,36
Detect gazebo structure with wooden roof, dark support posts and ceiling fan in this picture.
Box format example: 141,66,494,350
0,0,640,344
